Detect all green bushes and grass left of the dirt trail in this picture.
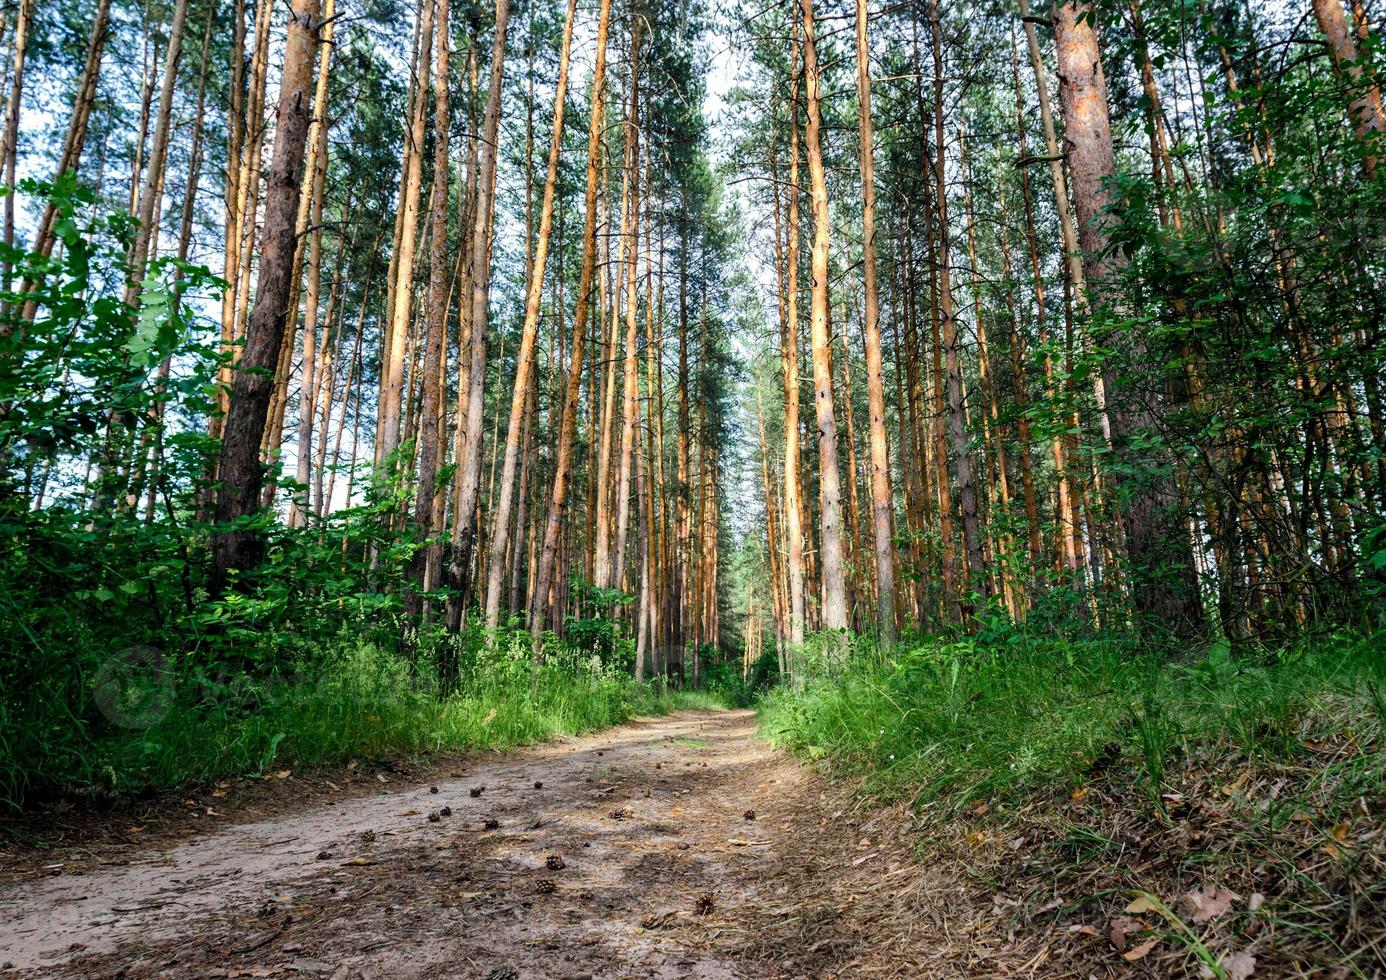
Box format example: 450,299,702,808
0,184,701,807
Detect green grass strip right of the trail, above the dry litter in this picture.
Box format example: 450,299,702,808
761,635,1386,810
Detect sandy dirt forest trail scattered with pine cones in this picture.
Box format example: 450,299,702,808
0,711,930,980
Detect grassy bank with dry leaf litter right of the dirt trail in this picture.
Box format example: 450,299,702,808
761,633,1386,980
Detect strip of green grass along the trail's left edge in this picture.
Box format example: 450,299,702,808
0,643,715,808
